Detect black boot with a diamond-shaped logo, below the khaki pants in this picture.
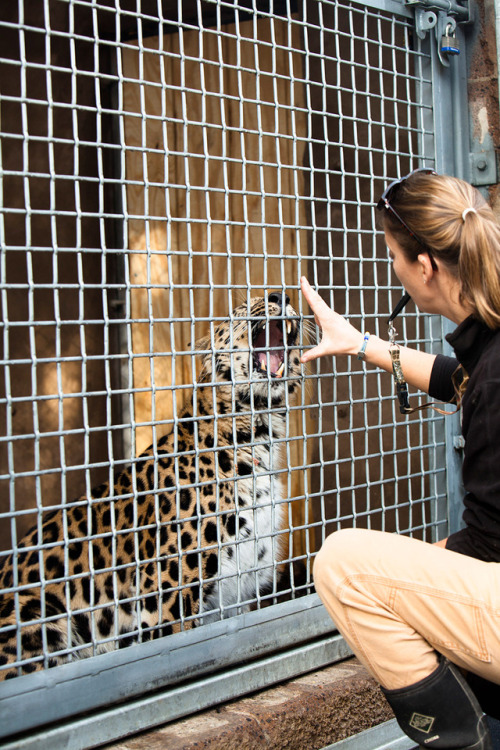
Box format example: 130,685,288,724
382,659,492,750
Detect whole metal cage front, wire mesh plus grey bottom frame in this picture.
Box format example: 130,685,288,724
0,0,466,748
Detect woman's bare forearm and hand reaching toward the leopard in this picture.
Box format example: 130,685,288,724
300,277,436,393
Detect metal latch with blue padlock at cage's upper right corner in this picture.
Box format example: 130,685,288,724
404,0,473,67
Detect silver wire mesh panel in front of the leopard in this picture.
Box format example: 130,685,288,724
0,0,446,676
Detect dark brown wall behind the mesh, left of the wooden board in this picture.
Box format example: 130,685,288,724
0,3,120,548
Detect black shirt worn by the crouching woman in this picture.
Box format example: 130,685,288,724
429,316,500,562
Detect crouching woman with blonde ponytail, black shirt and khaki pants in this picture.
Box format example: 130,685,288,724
301,170,500,750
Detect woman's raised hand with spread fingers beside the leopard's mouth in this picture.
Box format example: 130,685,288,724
300,276,363,362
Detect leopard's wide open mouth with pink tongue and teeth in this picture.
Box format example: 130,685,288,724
252,320,297,378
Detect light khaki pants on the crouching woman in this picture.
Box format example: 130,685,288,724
314,529,500,689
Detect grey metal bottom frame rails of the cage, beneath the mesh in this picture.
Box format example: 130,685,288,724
0,594,350,750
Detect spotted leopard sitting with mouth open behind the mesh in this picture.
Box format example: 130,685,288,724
0,291,301,679
